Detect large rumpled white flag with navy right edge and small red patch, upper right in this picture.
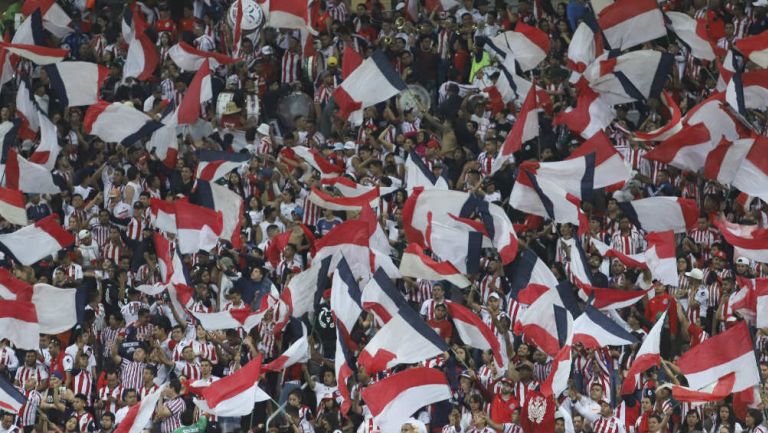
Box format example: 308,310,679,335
584,49,675,105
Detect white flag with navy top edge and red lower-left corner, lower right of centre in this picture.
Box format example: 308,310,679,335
573,305,637,349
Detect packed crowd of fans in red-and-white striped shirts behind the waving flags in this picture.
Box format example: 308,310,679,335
0,0,768,433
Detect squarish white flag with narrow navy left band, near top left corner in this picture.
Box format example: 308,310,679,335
44,62,109,107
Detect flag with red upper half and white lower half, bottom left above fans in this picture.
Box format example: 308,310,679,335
194,355,269,417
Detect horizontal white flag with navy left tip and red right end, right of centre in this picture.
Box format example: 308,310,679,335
619,197,699,233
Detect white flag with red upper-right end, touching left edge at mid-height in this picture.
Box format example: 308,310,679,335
0,214,75,266
